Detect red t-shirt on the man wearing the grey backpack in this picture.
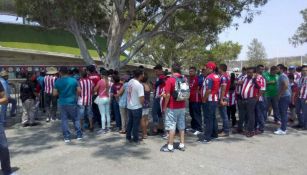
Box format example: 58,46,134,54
164,73,185,109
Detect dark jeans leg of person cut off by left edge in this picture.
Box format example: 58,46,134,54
0,122,12,175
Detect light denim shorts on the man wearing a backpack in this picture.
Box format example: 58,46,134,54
165,108,185,131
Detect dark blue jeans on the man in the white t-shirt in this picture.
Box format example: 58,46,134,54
126,108,142,142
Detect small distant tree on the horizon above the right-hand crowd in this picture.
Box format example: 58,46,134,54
247,38,267,66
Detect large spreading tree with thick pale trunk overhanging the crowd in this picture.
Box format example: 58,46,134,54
16,0,267,69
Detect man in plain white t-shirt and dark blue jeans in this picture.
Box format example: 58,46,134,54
126,69,145,143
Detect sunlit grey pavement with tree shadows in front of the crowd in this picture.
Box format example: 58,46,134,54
2,122,307,175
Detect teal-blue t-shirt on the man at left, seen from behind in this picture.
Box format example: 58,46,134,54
55,77,79,105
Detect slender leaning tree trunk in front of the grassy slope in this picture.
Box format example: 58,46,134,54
69,19,95,65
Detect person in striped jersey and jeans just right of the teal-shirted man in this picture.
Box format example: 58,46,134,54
78,71,94,132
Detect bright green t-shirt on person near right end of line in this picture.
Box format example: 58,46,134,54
263,72,278,97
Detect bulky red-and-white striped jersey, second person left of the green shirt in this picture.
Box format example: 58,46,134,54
241,77,261,99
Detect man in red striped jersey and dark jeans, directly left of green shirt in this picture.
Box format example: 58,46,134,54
255,65,266,134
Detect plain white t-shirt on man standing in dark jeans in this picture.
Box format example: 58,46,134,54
127,79,144,110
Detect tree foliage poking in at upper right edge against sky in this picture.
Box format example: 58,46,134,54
289,8,307,47
